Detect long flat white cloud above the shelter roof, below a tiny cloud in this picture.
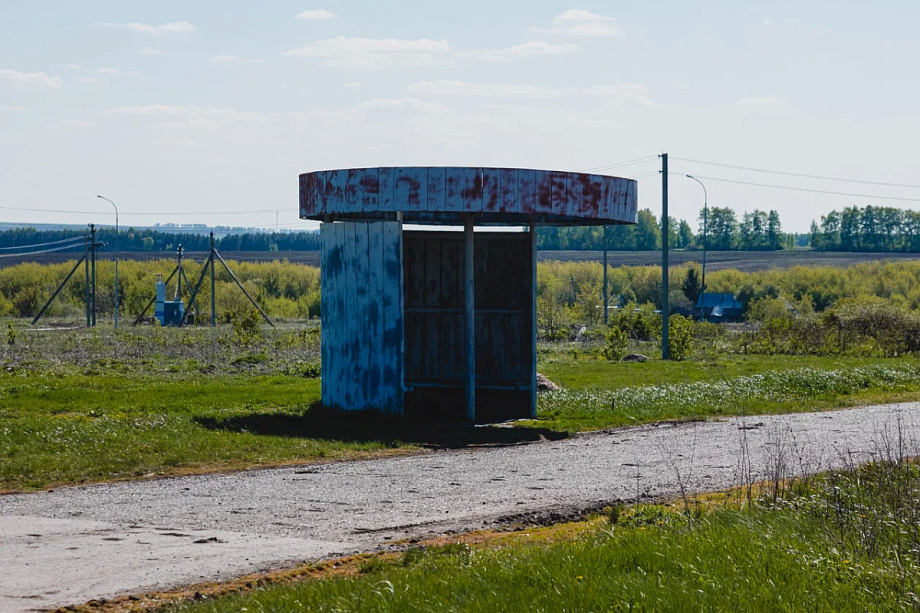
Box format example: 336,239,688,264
283,36,450,70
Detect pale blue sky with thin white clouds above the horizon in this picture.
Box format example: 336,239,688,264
0,0,920,232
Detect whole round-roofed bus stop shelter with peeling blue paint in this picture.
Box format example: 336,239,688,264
300,167,638,422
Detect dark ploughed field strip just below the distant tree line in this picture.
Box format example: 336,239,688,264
0,250,920,272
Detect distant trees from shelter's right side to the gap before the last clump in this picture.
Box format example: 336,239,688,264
537,207,801,251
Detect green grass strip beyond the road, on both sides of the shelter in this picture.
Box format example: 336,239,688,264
0,358,920,491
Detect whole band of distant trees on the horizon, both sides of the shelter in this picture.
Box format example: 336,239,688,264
0,206,920,255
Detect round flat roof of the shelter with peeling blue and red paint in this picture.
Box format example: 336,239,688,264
300,166,638,225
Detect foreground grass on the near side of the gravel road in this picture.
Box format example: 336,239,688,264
165,458,920,613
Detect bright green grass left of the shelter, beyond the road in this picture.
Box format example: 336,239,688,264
0,373,402,489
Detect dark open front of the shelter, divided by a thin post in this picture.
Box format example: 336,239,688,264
403,231,535,421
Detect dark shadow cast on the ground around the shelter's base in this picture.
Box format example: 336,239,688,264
195,405,569,449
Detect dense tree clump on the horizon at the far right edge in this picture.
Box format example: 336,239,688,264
810,205,920,253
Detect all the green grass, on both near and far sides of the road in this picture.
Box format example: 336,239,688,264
0,330,920,613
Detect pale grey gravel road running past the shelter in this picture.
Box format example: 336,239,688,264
0,403,920,611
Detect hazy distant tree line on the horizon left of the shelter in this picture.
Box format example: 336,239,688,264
0,228,322,253
